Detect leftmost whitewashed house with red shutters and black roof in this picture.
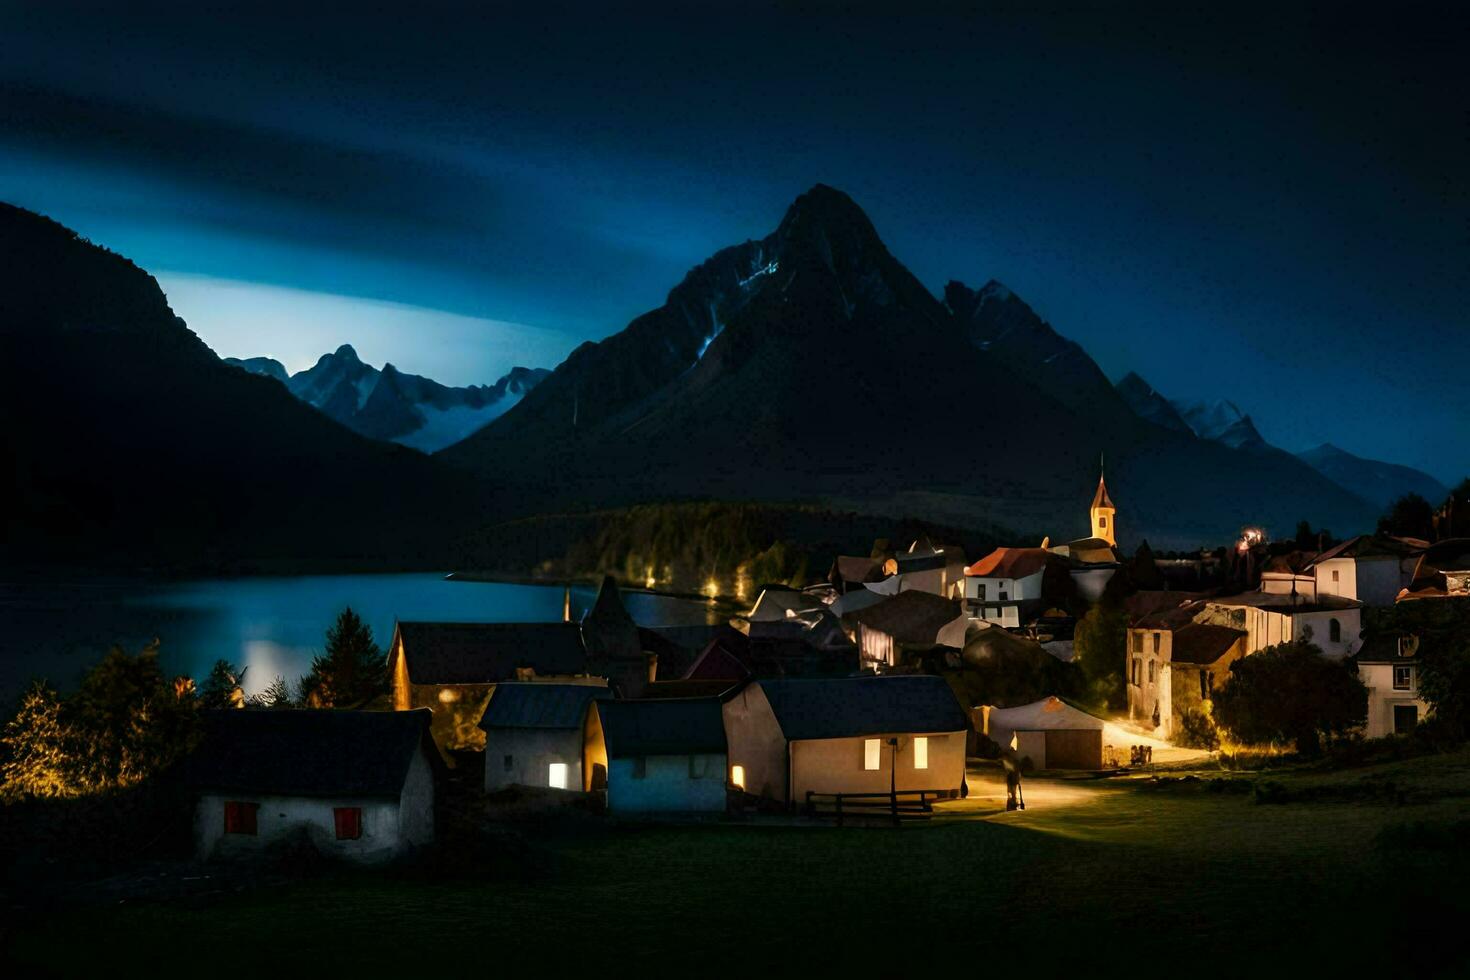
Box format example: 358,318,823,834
184,710,441,864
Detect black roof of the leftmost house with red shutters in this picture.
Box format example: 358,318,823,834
184,708,437,799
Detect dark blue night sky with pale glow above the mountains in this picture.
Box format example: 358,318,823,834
0,3,1470,480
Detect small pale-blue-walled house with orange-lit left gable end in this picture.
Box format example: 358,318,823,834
584,698,728,814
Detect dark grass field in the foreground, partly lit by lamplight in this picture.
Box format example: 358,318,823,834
0,752,1470,977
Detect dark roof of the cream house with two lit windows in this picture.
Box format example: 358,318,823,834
757,674,970,742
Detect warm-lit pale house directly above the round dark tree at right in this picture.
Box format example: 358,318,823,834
1194,592,1363,660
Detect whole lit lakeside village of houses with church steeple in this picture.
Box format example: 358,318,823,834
163,478,1470,864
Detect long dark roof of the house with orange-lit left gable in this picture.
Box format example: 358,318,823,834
390,623,587,685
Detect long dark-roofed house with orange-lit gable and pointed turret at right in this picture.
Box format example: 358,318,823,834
388,577,646,751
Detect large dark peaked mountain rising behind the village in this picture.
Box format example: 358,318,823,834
441,185,1372,547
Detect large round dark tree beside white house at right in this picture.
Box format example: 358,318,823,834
1214,636,1369,754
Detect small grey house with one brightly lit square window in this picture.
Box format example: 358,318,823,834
479,682,613,793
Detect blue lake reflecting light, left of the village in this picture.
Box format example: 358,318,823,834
0,573,710,705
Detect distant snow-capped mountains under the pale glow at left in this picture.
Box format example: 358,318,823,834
225,344,551,453
